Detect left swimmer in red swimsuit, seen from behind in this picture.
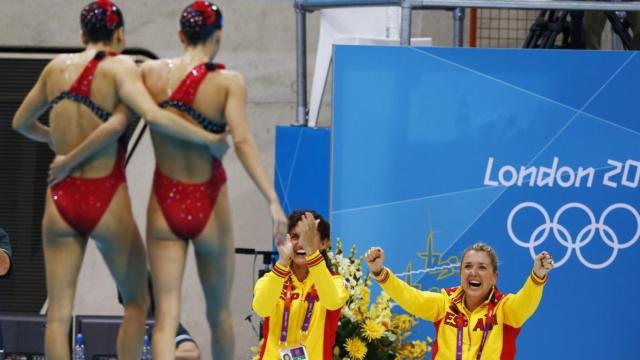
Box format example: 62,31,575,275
13,0,226,360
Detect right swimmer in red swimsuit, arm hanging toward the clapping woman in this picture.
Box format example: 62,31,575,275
142,1,287,360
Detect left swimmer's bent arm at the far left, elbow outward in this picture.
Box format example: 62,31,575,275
12,65,53,148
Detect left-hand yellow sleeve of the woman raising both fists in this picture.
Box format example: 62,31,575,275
375,268,446,321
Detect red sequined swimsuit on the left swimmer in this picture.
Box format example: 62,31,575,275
49,51,126,235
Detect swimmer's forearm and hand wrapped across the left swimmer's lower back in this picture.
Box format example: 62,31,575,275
47,104,129,185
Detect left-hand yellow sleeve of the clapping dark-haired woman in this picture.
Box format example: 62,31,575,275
252,263,291,317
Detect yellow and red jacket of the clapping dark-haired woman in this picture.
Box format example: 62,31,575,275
253,251,349,360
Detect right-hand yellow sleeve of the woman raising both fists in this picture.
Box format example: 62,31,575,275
504,272,548,327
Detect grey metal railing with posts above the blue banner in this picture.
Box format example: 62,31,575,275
293,0,640,125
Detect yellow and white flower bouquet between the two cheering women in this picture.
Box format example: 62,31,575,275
329,239,432,360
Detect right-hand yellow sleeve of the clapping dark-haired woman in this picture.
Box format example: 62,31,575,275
307,251,349,310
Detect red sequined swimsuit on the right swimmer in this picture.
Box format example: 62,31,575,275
153,63,227,240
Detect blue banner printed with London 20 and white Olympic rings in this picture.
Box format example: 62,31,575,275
331,46,640,360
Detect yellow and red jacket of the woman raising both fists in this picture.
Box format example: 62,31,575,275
376,268,547,360
